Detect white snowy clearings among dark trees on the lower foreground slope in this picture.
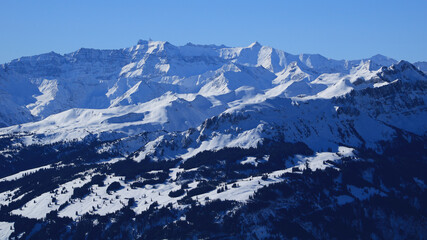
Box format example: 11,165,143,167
7,146,358,219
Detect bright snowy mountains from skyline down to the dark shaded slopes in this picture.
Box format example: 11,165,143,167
0,40,425,144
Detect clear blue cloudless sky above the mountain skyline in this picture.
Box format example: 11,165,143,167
0,0,427,63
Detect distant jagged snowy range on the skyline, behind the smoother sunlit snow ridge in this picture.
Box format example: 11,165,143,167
0,40,423,130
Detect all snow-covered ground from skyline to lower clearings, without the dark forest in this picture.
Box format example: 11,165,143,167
0,41,427,221
